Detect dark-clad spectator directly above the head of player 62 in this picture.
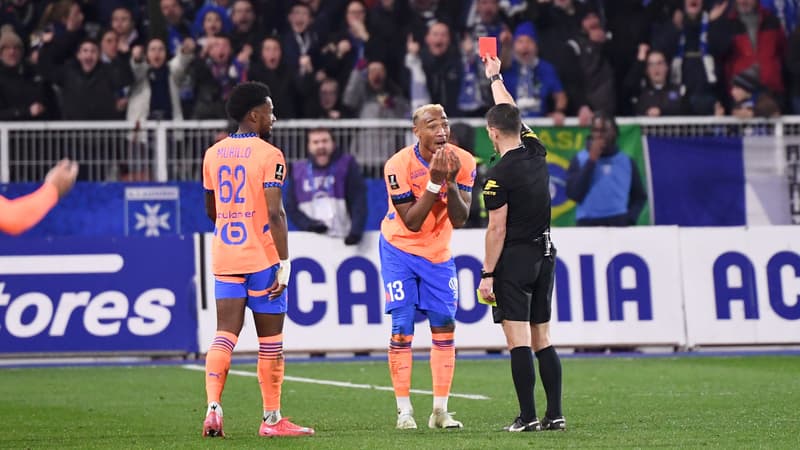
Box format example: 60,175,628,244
247,36,304,119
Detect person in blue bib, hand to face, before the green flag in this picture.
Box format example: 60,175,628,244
567,113,647,226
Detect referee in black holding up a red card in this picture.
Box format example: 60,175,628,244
479,55,566,432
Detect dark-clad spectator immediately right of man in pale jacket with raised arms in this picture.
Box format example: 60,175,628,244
191,35,250,119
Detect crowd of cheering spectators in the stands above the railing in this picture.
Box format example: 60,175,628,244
0,0,800,125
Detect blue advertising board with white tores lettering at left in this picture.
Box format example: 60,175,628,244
0,236,197,353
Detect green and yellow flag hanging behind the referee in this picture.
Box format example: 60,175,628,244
475,125,650,227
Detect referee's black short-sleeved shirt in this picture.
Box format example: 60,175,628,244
483,124,550,243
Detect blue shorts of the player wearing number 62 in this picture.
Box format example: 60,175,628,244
214,264,286,314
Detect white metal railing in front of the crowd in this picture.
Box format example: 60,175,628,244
0,116,800,223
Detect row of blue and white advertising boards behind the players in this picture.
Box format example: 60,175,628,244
0,226,800,356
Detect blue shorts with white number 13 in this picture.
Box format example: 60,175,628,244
378,236,458,318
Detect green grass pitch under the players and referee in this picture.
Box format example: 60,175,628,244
0,356,800,450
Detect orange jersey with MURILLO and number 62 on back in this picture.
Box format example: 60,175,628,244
203,133,287,275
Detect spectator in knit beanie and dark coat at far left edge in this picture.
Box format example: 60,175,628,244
0,25,48,120
